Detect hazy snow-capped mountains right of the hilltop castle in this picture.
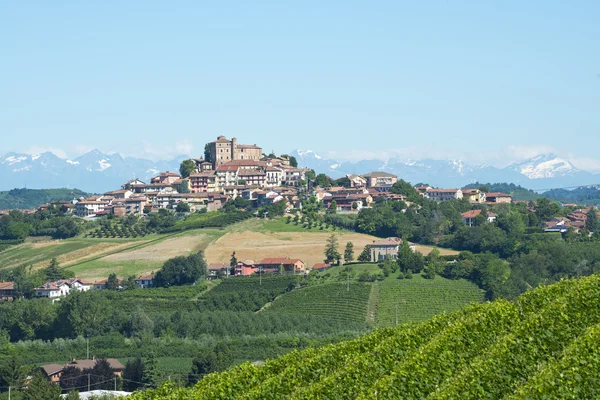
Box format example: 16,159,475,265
290,150,600,190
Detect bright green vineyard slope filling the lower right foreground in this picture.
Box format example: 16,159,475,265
131,276,600,400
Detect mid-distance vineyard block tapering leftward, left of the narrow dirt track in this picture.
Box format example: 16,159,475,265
267,283,371,324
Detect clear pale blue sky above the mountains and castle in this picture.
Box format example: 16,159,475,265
0,0,600,172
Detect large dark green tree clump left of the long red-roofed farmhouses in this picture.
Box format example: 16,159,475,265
154,251,206,287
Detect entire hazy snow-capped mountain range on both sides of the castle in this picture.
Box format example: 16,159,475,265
0,150,600,193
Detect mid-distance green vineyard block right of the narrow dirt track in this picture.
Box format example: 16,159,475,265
377,275,483,327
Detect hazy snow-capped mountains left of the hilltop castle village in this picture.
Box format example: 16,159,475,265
0,150,187,193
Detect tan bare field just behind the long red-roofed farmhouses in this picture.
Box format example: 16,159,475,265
205,232,377,267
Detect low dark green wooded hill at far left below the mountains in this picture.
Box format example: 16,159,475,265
0,189,87,210
